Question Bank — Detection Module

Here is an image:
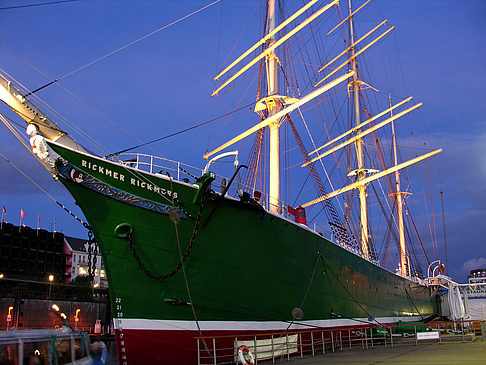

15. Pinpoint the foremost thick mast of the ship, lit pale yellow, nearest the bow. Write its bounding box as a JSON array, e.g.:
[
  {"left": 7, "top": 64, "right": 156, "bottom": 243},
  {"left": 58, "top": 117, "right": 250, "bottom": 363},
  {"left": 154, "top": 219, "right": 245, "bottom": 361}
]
[{"left": 266, "top": 0, "right": 281, "bottom": 213}]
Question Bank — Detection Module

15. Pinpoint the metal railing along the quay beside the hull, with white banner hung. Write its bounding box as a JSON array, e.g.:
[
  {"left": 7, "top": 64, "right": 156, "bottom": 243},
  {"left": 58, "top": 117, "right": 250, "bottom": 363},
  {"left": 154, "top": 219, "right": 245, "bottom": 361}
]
[{"left": 196, "top": 321, "right": 486, "bottom": 365}]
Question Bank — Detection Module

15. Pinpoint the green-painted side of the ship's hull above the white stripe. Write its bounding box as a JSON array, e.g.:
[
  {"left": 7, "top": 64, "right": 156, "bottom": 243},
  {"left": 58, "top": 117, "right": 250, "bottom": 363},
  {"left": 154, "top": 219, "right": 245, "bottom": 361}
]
[{"left": 53, "top": 141, "right": 438, "bottom": 322}]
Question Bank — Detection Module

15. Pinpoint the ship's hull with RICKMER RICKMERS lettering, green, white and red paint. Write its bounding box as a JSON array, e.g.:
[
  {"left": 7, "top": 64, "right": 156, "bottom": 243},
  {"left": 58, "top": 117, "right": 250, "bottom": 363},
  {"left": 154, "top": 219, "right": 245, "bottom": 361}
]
[{"left": 51, "top": 144, "right": 438, "bottom": 364}]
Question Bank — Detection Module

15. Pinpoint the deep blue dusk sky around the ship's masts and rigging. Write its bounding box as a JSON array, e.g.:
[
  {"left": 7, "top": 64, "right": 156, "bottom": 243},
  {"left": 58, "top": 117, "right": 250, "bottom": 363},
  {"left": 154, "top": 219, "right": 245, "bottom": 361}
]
[{"left": 0, "top": 0, "right": 486, "bottom": 281}]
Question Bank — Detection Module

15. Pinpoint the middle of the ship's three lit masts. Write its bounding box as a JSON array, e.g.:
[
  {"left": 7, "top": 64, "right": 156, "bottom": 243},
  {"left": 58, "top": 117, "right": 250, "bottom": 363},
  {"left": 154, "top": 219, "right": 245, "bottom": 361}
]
[{"left": 348, "top": 0, "right": 370, "bottom": 258}]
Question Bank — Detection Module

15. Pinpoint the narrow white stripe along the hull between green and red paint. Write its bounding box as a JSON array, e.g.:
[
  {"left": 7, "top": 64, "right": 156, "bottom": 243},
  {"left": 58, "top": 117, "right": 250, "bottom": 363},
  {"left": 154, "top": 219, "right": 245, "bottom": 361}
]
[{"left": 113, "top": 316, "right": 422, "bottom": 332}]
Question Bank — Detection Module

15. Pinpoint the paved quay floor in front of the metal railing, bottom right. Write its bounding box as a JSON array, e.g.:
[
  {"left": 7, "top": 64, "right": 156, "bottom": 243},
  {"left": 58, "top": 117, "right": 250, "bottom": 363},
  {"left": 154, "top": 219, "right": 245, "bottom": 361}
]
[{"left": 290, "top": 339, "right": 486, "bottom": 365}]
